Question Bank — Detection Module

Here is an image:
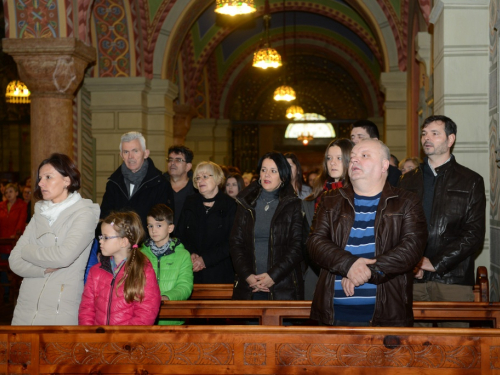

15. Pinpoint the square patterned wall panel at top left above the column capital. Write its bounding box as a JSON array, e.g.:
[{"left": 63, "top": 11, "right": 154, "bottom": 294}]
[{"left": 10, "top": 0, "right": 59, "bottom": 38}]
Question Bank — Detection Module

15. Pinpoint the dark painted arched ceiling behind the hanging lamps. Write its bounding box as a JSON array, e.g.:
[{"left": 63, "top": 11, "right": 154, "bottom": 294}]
[{"left": 164, "top": 0, "right": 408, "bottom": 120}]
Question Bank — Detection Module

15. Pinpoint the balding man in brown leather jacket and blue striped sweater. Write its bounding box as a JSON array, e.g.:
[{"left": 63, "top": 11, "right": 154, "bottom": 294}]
[{"left": 307, "top": 139, "right": 427, "bottom": 326}]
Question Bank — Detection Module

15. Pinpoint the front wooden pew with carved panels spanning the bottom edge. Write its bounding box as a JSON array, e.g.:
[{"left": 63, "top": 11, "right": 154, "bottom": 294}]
[{"left": 0, "top": 326, "right": 500, "bottom": 375}]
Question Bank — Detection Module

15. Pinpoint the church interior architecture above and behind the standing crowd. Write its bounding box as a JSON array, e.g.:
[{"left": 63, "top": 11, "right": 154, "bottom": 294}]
[{"left": 0, "top": 0, "right": 500, "bottom": 301}]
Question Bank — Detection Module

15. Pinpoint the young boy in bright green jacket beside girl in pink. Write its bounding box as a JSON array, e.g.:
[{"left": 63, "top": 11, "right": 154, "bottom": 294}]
[{"left": 141, "top": 203, "right": 193, "bottom": 325}]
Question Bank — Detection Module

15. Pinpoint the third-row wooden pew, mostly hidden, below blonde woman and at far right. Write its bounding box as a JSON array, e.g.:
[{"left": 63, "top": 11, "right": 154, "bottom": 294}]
[{"left": 189, "top": 266, "right": 490, "bottom": 302}]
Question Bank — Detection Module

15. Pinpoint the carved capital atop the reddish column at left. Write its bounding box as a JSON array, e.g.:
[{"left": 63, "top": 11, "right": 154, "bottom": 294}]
[{"left": 2, "top": 38, "right": 96, "bottom": 99}]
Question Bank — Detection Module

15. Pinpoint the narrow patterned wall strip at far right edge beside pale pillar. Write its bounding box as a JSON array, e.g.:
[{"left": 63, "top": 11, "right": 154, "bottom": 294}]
[{"left": 489, "top": 0, "right": 500, "bottom": 301}]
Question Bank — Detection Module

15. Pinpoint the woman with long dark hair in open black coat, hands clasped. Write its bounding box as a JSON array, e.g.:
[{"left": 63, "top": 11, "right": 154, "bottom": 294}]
[{"left": 230, "top": 152, "right": 304, "bottom": 300}]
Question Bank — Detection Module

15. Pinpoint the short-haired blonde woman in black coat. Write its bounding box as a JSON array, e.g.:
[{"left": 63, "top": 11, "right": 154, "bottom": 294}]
[{"left": 175, "top": 161, "right": 236, "bottom": 284}]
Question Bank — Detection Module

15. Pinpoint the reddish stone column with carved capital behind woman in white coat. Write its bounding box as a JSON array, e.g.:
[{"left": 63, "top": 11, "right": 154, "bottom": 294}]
[{"left": 2, "top": 38, "right": 96, "bottom": 181}]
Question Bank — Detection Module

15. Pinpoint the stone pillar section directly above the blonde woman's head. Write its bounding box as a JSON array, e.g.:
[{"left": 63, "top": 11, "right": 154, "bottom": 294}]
[{"left": 185, "top": 119, "right": 232, "bottom": 168}]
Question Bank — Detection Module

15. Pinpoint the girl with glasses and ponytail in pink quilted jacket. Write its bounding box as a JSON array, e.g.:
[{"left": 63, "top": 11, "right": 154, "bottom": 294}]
[{"left": 78, "top": 212, "right": 161, "bottom": 325}]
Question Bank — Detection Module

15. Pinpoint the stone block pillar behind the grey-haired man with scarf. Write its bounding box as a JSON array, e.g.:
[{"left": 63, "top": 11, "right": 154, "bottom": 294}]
[{"left": 84, "top": 77, "right": 178, "bottom": 206}]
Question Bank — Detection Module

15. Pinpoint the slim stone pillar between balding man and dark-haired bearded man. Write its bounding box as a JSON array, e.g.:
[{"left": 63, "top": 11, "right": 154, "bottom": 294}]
[{"left": 380, "top": 72, "right": 407, "bottom": 160}]
